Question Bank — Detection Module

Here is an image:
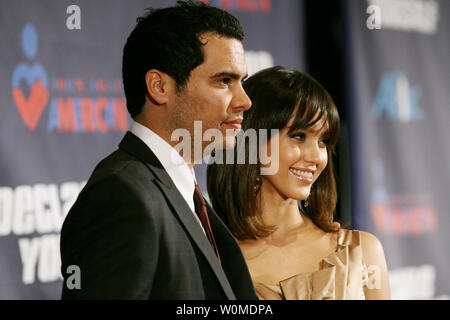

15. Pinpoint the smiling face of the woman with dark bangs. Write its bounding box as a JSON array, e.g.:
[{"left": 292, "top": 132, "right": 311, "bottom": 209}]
[{"left": 261, "top": 117, "right": 328, "bottom": 200}]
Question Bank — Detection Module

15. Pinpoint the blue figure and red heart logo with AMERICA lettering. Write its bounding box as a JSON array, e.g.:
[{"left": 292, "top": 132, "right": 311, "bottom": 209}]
[{"left": 12, "top": 23, "right": 128, "bottom": 133}]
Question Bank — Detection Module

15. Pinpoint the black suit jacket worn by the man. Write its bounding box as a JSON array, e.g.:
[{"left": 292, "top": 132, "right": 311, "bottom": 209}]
[{"left": 61, "top": 132, "right": 257, "bottom": 299}]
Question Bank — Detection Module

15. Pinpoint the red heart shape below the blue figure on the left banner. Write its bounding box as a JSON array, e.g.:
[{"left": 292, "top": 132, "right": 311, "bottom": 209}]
[{"left": 13, "top": 79, "right": 49, "bottom": 131}]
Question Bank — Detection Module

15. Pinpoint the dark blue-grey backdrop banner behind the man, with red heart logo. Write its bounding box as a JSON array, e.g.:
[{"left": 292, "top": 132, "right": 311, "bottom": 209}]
[{"left": 0, "top": 0, "right": 304, "bottom": 299}]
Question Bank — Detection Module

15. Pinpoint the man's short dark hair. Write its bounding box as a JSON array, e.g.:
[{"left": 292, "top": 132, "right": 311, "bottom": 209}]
[{"left": 122, "top": 1, "right": 244, "bottom": 117}]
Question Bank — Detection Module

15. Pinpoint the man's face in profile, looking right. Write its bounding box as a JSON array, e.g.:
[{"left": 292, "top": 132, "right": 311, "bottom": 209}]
[{"left": 172, "top": 33, "right": 251, "bottom": 160}]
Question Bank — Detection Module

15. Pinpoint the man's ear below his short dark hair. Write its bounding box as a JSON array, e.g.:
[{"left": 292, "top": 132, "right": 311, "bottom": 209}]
[{"left": 145, "top": 69, "right": 175, "bottom": 105}]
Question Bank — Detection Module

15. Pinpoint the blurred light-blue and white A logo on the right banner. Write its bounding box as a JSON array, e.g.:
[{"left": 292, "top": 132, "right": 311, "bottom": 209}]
[{"left": 371, "top": 72, "right": 424, "bottom": 122}]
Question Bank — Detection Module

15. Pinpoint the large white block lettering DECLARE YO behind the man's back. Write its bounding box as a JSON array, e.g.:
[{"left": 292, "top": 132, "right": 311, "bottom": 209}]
[{"left": 0, "top": 181, "right": 86, "bottom": 285}]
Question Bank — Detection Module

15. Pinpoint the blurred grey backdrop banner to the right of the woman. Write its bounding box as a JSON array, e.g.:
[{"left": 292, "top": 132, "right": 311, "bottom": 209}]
[{"left": 345, "top": 0, "right": 450, "bottom": 299}]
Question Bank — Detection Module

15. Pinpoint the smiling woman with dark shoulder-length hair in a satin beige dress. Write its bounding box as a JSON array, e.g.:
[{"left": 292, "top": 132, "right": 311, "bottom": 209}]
[{"left": 207, "top": 67, "right": 390, "bottom": 299}]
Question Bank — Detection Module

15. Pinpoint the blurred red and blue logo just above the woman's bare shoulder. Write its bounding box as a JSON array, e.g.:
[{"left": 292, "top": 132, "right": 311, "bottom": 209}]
[{"left": 370, "top": 159, "right": 438, "bottom": 236}]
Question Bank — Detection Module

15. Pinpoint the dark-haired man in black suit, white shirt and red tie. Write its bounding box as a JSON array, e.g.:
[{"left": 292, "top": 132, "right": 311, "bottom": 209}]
[{"left": 61, "top": 1, "right": 257, "bottom": 299}]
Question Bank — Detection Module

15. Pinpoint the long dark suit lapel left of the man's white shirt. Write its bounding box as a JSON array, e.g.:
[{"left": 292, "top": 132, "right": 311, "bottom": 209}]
[{"left": 119, "top": 132, "right": 236, "bottom": 299}]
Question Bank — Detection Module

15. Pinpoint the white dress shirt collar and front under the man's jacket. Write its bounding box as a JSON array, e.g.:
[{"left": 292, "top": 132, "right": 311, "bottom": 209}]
[{"left": 130, "top": 121, "right": 204, "bottom": 231}]
